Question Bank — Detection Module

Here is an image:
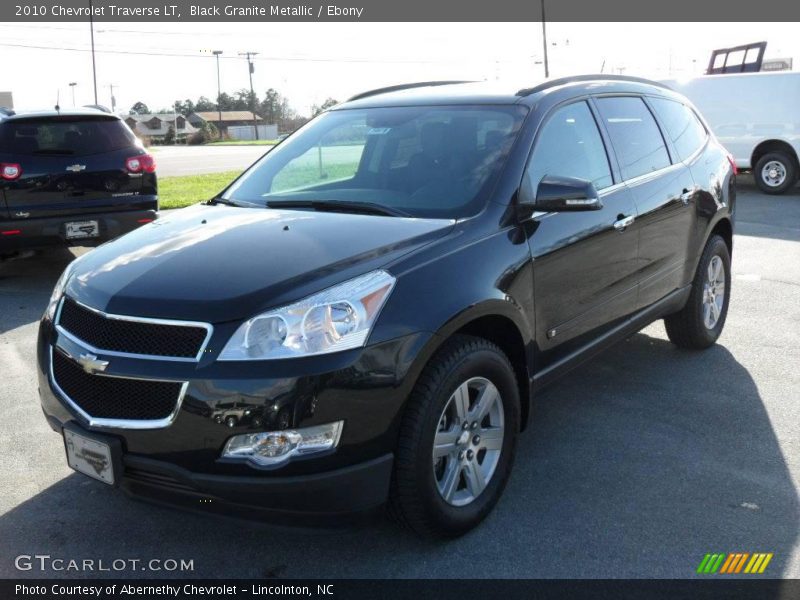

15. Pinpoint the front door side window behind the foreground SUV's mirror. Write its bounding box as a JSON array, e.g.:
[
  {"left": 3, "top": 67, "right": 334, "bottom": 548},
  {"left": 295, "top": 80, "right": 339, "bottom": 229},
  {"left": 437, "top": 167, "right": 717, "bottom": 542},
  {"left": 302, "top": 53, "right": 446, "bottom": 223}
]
[{"left": 525, "top": 102, "right": 613, "bottom": 190}]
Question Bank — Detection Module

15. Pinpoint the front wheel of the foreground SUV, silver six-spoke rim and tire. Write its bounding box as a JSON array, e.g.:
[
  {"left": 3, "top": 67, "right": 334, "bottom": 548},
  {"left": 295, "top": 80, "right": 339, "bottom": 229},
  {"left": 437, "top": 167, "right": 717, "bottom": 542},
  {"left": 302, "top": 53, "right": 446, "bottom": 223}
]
[{"left": 390, "top": 336, "right": 520, "bottom": 538}]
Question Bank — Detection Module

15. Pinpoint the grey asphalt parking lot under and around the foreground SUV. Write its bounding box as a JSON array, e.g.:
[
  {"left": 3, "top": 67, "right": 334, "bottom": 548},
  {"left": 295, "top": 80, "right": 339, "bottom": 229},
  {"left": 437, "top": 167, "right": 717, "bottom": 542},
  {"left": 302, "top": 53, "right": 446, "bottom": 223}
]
[{"left": 0, "top": 177, "right": 800, "bottom": 578}]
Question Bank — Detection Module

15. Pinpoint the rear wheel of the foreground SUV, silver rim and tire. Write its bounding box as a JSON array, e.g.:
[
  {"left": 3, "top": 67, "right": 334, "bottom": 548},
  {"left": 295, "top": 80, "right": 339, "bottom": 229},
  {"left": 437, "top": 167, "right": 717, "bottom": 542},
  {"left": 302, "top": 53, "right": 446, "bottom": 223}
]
[{"left": 664, "top": 235, "right": 731, "bottom": 349}]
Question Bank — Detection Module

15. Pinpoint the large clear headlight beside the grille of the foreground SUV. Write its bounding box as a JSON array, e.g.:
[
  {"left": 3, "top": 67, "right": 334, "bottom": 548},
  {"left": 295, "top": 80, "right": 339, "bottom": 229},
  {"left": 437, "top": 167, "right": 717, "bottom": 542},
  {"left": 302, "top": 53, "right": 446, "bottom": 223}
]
[{"left": 218, "top": 271, "right": 395, "bottom": 360}]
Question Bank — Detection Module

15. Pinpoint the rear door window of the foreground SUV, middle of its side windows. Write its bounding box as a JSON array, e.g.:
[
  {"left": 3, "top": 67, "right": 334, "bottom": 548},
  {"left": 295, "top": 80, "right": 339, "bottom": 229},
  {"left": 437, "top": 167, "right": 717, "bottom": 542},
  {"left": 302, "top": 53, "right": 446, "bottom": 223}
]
[{"left": 597, "top": 97, "right": 670, "bottom": 179}]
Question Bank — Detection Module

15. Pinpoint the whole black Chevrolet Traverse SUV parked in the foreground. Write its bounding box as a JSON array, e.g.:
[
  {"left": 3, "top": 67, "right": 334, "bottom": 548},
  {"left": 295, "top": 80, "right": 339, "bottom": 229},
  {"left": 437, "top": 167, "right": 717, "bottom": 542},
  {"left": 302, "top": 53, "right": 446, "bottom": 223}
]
[{"left": 38, "top": 76, "right": 735, "bottom": 537}]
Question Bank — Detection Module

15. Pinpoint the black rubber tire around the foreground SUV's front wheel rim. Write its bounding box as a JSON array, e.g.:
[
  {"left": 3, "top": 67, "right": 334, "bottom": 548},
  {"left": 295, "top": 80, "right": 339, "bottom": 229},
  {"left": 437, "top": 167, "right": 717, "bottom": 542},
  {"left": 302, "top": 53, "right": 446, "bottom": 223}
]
[{"left": 389, "top": 335, "right": 520, "bottom": 538}]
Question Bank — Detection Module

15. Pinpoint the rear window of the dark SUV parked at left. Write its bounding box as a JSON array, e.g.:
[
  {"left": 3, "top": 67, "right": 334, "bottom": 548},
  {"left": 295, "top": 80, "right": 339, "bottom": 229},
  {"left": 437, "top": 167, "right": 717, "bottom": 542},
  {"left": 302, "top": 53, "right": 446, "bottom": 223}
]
[{"left": 0, "top": 118, "right": 136, "bottom": 156}]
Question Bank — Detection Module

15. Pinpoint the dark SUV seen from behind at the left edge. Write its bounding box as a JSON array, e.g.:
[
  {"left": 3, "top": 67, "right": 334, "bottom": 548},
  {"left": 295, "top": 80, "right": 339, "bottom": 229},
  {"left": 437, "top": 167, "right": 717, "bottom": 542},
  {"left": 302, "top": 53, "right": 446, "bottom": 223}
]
[{"left": 0, "top": 108, "right": 158, "bottom": 254}]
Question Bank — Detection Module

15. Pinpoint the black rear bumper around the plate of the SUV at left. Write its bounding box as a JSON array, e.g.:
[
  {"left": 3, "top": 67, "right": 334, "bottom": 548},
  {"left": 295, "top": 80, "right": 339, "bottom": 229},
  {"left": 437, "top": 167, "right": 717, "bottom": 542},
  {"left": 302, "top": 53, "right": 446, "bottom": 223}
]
[{"left": 0, "top": 210, "right": 158, "bottom": 252}]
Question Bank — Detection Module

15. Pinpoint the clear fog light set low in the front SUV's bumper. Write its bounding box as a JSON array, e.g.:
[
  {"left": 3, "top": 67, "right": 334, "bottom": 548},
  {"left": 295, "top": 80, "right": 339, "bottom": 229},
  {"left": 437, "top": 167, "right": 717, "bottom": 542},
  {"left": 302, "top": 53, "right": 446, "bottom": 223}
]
[{"left": 222, "top": 421, "right": 344, "bottom": 467}]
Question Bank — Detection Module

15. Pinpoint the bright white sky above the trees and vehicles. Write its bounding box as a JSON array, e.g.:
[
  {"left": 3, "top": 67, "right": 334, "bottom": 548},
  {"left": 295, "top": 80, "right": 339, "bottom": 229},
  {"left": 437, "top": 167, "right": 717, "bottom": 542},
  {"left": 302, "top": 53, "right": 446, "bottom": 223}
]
[{"left": 0, "top": 23, "right": 800, "bottom": 114}]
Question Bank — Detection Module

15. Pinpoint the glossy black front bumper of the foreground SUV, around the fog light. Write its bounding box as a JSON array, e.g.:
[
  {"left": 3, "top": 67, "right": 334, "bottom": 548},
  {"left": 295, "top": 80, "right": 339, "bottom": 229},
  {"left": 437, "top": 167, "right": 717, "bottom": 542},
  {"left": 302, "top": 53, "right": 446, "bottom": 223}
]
[{"left": 38, "top": 319, "right": 430, "bottom": 524}]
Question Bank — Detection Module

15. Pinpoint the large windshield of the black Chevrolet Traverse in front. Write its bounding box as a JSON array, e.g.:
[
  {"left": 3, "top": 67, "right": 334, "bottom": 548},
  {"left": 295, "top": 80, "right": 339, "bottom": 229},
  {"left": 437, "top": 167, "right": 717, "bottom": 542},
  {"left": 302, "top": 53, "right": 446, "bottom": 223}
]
[{"left": 222, "top": 106, "right": 526, "bottom": 218}]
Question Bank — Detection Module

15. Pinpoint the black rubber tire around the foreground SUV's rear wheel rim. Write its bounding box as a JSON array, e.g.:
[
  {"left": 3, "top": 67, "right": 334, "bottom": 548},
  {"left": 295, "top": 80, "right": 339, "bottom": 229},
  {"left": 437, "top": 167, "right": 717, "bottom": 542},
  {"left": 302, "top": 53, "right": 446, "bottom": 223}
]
[{"left": 664, "top": 235, "right": 731, "bottom": 350}]
